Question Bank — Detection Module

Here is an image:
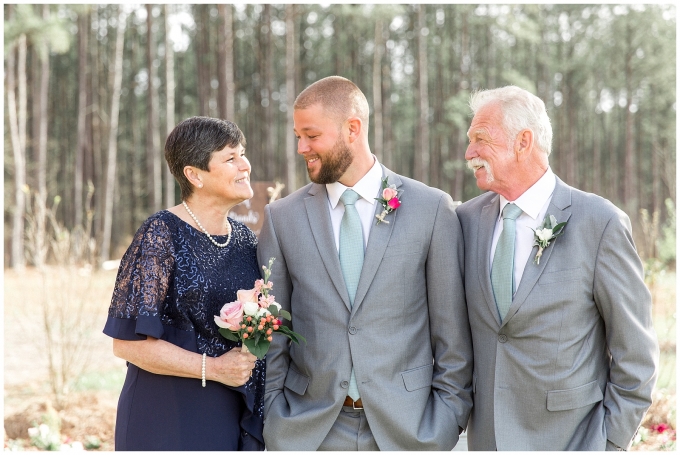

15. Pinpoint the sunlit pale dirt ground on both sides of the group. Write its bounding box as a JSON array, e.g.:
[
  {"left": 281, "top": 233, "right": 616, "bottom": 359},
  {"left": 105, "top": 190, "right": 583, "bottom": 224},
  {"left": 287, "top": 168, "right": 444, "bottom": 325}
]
[{"left": 3, "top": 269, "right": 676, "bottom": 451}]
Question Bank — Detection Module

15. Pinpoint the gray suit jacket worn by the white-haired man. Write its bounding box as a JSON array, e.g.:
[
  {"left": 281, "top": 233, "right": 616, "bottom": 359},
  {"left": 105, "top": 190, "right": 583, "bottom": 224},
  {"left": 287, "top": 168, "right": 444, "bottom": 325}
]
[{"left": 456, "top": 179, "right": 658, "bottom": 450}]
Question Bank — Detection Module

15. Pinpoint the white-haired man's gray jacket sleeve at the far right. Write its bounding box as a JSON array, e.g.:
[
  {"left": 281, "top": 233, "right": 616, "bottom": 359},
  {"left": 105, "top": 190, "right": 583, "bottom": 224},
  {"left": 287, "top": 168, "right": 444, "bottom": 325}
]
[{"left": 596, "top": 211, "right": 659, "bottom": 448}]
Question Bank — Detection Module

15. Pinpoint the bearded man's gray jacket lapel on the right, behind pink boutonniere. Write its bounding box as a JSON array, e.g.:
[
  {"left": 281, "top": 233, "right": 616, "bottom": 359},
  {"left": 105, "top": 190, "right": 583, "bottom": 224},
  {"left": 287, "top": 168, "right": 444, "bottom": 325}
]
[{"left": 354, "top": 166, "right": 401, "bottom": 313}]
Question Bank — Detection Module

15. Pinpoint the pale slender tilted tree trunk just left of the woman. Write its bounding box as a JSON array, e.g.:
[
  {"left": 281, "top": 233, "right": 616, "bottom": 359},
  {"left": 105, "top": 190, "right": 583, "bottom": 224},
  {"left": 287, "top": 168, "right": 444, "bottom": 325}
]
[{"left": 99, "top": 5, "right": 126, "bottom": 262}]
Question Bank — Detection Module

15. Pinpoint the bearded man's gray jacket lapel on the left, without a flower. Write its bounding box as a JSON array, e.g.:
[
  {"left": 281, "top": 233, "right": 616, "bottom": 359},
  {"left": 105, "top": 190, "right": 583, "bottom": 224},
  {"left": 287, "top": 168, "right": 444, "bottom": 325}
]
[{"left": 305, "top": 184, "right": 354, "bottom": 311}]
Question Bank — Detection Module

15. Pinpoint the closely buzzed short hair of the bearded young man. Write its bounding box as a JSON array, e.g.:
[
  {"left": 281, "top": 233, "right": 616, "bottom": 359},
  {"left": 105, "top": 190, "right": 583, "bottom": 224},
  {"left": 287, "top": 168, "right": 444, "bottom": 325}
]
[{"left": 293, "top": 76, "right": 368, "bottom": 131}]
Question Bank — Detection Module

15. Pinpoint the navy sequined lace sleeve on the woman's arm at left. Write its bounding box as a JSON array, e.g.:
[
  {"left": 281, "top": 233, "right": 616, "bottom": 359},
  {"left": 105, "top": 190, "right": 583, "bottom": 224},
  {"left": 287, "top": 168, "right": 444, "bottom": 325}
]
[{"left": 104, "top": 217, "right": 175, "bottom": 340}]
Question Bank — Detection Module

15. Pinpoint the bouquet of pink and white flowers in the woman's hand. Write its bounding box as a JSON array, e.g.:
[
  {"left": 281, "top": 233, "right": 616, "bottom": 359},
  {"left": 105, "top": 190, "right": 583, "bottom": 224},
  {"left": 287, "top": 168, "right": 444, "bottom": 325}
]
[{"left": 215, "top": 258, "right": 306, "bottom": 359}]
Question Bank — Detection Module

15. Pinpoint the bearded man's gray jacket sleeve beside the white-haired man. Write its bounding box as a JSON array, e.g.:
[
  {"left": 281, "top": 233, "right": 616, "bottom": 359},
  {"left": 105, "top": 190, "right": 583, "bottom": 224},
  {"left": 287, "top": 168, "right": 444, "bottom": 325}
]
[{"left": 421, "top": 194, "right": 472, "bottom": 432}]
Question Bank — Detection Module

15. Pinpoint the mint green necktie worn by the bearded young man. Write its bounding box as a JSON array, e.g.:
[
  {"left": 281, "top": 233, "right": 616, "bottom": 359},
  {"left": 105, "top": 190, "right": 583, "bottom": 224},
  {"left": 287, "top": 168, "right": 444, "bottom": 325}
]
[{"left": 339, "top": 188, "right": 364, "bottom": 401}]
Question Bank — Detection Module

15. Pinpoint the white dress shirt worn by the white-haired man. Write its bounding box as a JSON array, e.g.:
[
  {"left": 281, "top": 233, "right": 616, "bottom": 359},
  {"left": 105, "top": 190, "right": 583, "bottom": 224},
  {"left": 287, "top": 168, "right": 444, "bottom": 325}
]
[{"left": 489, "top": 167, "right": 556, "bottom": 295}]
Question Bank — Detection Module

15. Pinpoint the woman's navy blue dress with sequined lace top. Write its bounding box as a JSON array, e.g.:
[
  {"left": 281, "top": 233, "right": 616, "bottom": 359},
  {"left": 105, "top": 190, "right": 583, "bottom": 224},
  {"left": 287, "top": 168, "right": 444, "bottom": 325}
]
[{"left": 104, "top": 210, "right": 265, "bottom": 450}]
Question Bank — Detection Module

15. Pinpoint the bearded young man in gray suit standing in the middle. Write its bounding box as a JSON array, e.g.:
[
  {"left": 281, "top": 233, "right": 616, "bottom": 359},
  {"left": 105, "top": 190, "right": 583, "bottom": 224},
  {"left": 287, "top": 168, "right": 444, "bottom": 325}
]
[{"left": 258, "top": 76, "right": 472, "bottom": 450}]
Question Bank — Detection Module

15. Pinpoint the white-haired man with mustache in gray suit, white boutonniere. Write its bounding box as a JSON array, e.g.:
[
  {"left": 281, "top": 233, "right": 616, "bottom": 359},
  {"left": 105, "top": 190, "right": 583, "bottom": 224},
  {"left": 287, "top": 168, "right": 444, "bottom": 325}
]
[{"left": 456, "top": 86, "right": 658, "bottom": 450}]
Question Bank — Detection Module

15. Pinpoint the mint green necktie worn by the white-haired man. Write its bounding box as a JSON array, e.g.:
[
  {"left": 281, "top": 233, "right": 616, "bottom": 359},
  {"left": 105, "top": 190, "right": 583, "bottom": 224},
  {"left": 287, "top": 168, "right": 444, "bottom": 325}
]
[{"left": 491, "top": 204, "right": 522, "bottom": 321}]
